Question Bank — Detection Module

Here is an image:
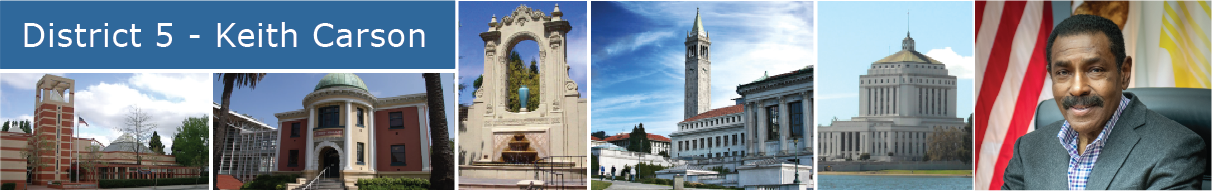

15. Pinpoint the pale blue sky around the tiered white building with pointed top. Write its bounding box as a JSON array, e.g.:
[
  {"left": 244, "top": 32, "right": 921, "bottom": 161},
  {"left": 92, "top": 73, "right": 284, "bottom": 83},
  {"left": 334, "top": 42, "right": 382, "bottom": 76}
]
[{"left": 817, "top": 1, "right": 976, "bottom": 125}]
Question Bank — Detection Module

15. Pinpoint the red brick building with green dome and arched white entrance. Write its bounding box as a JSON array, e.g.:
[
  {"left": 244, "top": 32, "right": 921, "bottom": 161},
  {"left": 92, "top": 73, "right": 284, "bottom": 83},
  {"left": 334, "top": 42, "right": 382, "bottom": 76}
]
[{"left": 274, "top": 74, "right": 430, "bottom": 183}]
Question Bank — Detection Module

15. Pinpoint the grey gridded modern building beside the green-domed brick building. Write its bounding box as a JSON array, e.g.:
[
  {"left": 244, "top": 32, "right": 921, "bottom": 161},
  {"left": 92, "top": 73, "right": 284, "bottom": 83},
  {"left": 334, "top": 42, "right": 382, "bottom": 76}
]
[{"left": 211, "top": 104, "right": 278, "bottom": 181}]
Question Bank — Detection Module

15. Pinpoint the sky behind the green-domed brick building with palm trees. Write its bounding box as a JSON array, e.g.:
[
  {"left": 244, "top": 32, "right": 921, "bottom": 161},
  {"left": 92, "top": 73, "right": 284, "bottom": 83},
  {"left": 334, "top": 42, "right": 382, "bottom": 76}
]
[{"left": 211, "top": 74, "right": 457, "bottom": 139}]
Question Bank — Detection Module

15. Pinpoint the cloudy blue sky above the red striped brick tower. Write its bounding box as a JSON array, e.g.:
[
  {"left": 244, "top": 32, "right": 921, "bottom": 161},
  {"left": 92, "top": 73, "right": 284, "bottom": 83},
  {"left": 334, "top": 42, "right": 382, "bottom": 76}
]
[{"left": 0, "top": 74, "right": 211, "bottom": 152}]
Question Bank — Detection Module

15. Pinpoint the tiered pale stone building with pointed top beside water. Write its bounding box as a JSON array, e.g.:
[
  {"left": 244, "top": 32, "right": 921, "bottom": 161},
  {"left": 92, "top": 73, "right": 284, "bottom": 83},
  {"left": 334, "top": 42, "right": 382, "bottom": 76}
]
[{"left": 819, "top": 33, "right": 965, "bottom": 161}]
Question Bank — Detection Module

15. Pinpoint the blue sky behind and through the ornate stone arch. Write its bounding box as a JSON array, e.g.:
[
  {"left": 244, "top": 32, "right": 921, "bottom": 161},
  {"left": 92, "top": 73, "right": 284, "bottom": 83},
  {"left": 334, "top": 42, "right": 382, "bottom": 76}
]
[{"left": 458, "top": 1, "right": 589, "bottom": 104}]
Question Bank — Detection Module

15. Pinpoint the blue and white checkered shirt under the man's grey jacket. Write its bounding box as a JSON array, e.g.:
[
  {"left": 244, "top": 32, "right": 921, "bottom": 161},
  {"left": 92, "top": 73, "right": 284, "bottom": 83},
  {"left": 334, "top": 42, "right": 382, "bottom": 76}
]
[{"left": 1057, "top": 94, "right": 1131, "bottom": 191}]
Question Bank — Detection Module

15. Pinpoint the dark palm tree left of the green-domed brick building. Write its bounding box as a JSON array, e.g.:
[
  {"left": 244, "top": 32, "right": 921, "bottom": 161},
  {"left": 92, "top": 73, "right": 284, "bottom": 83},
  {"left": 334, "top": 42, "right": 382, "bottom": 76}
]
[{"left": 211, "top": 73, "right": 265, "bottom": 190}]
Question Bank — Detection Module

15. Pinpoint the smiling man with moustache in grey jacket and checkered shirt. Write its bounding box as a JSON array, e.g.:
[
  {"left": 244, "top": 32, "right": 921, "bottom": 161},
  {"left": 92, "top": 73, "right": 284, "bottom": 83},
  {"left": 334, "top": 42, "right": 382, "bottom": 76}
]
[{"left": 1001, "top": 15, "right": 1205, "bottom": 191}]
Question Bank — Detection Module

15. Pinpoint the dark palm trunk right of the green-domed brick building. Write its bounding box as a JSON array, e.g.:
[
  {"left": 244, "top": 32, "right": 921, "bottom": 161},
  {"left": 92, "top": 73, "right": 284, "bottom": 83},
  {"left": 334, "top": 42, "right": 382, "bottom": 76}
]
[{"left": 422, "top": 73, "right": 455, "bottom": 190}]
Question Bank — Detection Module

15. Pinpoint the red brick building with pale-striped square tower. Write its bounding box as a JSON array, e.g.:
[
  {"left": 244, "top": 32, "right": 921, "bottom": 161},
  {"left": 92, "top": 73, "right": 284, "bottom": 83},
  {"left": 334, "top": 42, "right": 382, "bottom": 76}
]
[{"left": 0, "top": 75, "right": 204, "bottom": 190}]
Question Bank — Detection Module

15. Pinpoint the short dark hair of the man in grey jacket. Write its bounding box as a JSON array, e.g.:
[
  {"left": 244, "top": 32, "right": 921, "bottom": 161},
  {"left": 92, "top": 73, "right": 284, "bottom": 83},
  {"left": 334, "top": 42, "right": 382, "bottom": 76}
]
[{"left": 1045, "top": 15, "right": 1127, "bottom": 73}]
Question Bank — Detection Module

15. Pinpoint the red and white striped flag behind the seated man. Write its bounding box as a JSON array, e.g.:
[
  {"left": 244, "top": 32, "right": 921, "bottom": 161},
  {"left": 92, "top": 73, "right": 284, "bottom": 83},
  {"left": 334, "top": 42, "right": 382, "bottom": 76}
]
[{"left": 974, "top": 0, "right": 1052, "bottom": 190}]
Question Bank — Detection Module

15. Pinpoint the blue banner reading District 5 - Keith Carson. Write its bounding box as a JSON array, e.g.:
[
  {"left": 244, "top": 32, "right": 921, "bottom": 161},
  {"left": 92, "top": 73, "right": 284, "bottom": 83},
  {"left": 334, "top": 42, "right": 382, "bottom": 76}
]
[{"left": 0, "top": 0, "right": 457, "bottom": 69}]
